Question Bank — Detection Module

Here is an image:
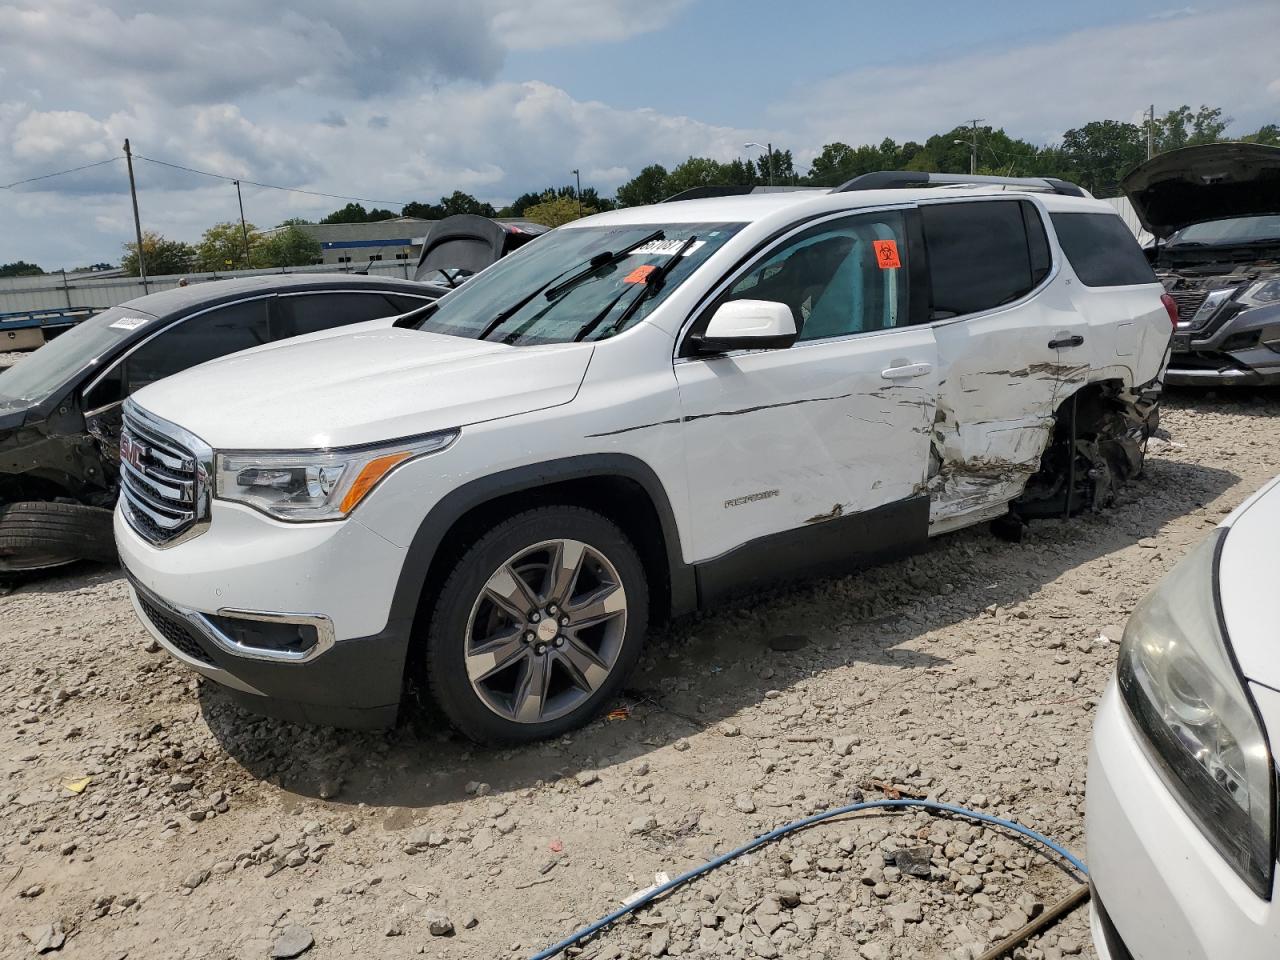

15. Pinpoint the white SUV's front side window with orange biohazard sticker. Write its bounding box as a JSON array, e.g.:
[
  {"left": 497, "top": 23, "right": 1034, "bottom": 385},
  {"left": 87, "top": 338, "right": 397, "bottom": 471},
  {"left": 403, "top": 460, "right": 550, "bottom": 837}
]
[{"left": 721, "top": 211, "right": 909, "bottom": 340}]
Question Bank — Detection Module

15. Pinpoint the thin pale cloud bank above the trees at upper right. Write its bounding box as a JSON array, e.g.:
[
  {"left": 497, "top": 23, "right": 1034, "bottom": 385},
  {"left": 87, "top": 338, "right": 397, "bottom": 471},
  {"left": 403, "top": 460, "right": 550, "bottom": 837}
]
[{"left": 768, "top": 0, "right": 1280, "bottom": 156}]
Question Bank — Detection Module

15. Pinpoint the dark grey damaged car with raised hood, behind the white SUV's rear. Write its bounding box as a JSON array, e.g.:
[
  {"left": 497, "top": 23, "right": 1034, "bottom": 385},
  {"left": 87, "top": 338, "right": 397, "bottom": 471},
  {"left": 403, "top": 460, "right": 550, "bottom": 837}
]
[{"left": 1121, "top": 143, "right": 1280, "bottom": 387}]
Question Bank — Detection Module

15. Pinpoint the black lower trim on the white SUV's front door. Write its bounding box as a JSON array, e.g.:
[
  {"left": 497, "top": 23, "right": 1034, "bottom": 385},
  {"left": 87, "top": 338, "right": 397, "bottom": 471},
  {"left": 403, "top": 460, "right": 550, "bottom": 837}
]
[{"left": 696, "top": 494, "right": 929, "bottom": 607}]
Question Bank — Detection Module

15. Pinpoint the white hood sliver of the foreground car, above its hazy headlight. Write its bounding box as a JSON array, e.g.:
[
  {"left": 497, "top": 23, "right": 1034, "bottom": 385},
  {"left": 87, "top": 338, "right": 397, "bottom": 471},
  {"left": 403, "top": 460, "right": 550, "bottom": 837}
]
[{"left": 1217, "top": 477, "right": 1280, "bottom": 690}]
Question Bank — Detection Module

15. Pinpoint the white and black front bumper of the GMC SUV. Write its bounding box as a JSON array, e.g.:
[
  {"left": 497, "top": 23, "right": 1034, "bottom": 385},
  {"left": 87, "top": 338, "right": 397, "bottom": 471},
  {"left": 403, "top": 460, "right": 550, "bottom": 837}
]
[{"left": 115, "top": 507, "right": 411, "bottom": 728}]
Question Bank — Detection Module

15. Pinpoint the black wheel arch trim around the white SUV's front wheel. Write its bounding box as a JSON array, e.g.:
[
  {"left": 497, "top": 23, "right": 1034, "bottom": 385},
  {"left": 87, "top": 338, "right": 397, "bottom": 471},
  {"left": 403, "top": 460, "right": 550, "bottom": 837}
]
[{"left": 390, "top": 453, "right": 698, "bottom": 670}]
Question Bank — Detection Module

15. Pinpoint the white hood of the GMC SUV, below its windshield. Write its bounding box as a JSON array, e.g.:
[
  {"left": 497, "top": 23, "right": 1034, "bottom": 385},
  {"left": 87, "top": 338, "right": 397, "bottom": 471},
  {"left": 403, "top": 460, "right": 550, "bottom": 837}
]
[{"left": 134, "top": 328, "right": 593, "bottom": 449}]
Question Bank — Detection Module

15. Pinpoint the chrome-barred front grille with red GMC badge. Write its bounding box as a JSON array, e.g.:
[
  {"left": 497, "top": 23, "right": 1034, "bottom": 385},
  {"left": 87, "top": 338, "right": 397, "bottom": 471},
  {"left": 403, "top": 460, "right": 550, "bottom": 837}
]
[{"left": 120, "top": 399, "right": 214, "bottom": 548}]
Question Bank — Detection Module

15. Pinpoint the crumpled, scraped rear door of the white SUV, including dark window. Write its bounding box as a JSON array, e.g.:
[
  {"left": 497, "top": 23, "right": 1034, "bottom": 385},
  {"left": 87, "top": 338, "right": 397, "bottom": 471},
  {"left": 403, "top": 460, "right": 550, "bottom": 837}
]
[{"left": 920, "top": 197, "right": 1089, "bottom": 534}]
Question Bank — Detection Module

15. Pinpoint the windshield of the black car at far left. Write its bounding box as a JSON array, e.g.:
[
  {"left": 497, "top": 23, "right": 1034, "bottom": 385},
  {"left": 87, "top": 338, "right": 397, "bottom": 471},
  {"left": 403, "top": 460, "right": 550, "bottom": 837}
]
[{"left": 0, "top": 306, "right": 155, "bottom": 402}]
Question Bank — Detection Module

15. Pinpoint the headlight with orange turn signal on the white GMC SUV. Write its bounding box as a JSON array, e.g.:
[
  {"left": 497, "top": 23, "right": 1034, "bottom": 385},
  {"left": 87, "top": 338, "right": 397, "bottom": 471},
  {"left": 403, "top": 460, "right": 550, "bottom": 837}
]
[{"left": 214, "top": 430, "right": 458, "bottom": 521}]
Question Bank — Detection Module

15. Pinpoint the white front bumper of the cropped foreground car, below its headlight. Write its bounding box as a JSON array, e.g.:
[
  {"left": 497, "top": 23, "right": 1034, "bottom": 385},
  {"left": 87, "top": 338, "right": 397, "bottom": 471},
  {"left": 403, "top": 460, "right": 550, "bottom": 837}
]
[{"left": 1085, "top": 681, "right": 1280, "bottom": 960}]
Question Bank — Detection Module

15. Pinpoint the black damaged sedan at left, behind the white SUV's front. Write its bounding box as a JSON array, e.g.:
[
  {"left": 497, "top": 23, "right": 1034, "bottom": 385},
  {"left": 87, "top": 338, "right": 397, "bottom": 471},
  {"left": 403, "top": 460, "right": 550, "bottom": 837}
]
[{"left": 0, "top": 274, "right": 448, "bottom": 573}]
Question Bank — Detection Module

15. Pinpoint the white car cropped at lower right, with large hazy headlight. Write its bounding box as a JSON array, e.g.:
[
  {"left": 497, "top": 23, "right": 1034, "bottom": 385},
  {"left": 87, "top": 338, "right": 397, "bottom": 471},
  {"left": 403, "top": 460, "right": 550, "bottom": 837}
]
[{"left": 1087, "top": 479, "right": 1280, "bottom": 960}]
